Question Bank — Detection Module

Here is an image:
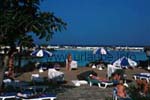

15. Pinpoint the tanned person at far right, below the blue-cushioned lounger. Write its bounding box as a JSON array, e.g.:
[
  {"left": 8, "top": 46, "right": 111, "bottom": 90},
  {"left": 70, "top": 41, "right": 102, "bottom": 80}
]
[{"left": 136, "top": 79, "right": 148, "bottom": 96}]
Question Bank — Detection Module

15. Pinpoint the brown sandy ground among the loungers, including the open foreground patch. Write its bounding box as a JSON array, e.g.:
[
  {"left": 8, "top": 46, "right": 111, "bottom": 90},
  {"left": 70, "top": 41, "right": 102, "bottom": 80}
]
[{"left": 13, "top": 67, "right": 148, "bottom": 100}]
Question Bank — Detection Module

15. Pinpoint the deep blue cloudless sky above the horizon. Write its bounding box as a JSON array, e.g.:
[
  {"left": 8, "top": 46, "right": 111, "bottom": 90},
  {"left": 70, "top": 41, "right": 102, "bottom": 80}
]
[{"left": 35, "top": 0, "right": 150, "bottom": 46}]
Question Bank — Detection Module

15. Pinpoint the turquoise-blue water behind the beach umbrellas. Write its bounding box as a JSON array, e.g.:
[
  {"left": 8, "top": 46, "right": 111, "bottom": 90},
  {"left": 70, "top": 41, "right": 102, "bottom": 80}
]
[{"left": 17, "top": 49, "right": 148, "bottom": 67}]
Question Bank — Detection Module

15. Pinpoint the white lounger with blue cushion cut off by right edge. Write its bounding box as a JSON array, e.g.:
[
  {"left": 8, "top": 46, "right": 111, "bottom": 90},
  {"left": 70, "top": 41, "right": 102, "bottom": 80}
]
[{"left": 133, "top": 73, "right": 150, "bottom": 83}]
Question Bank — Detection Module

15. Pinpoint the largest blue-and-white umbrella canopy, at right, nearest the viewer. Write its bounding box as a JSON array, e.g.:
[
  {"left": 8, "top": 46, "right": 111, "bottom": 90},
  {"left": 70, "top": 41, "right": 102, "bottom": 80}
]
[{"left": 113, "top": 57, "right": 137, "bottom": 67}]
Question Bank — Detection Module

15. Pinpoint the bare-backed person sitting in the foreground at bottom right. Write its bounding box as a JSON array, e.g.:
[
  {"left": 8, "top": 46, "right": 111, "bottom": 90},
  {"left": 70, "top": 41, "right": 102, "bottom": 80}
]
[{"left": 116, "top": 80, "right": 131, "bottom": 100}]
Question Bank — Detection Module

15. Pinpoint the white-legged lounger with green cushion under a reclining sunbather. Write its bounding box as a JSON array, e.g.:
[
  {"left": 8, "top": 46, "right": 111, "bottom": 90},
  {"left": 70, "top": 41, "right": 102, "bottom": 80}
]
[{"left": 87, "top": 76, "right": 113, "bottom": 89}]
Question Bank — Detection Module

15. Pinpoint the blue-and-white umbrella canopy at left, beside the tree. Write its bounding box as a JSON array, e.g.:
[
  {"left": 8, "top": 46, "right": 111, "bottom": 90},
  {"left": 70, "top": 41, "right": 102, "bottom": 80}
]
[{"left": 31, "top": 50, "right": 52, "bottom": 57}]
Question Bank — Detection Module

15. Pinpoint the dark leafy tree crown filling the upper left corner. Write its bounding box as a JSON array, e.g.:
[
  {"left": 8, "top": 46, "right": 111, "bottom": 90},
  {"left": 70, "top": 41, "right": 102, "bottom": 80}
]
[{"left": 0, "top": 0, "right": 66, "bottom": 89}]
